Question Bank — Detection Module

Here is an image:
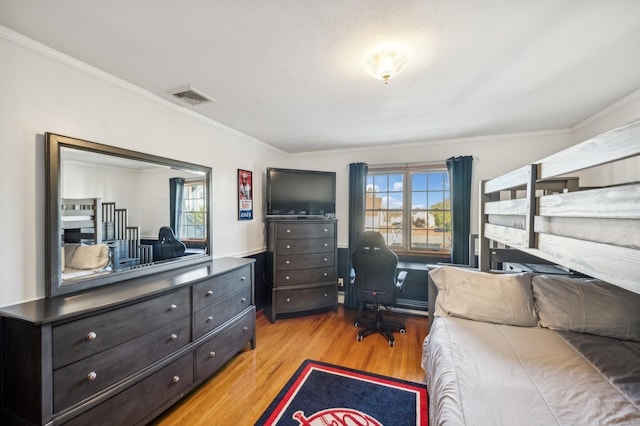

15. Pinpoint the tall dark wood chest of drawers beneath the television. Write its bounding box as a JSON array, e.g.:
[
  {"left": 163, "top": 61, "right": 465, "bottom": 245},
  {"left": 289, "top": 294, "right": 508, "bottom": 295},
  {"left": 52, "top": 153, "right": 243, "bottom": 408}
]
[{"left": 267, "top": 219, "right": 338, "bottom": 322}]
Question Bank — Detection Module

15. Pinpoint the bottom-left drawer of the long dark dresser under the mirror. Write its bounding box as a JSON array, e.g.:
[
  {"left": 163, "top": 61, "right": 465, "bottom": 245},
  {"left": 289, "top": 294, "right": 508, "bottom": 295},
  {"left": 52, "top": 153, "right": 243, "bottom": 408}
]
[{"left": 65, "top": 353, "right": 194, "bottom": 426}]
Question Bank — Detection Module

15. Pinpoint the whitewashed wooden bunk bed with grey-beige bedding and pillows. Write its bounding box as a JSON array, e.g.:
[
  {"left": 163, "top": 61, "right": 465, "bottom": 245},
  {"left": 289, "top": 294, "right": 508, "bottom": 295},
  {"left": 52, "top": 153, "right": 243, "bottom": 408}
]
[{"left": 422, "top": 120, "right": 640, "bottom": 425}]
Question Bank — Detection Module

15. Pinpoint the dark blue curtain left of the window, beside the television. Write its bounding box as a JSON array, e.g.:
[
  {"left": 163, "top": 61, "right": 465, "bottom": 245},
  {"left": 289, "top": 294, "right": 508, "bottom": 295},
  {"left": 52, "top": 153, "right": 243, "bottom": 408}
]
[{"left": 344, "top": 163, "right": 369, "bottom": 309}]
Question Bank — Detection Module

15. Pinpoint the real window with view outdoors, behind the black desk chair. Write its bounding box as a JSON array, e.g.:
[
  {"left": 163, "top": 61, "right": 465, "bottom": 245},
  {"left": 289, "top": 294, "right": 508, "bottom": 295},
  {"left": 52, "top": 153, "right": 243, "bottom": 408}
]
[{"left": 364, "top": 164, "right": 451, "bottom": 253}]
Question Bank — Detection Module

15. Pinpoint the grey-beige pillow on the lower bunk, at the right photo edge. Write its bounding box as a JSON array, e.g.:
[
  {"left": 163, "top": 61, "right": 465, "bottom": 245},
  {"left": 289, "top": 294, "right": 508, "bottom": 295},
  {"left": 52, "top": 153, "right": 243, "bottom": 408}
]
[{"left": 532, "top": 275, "right": 640, "bottom": 341}]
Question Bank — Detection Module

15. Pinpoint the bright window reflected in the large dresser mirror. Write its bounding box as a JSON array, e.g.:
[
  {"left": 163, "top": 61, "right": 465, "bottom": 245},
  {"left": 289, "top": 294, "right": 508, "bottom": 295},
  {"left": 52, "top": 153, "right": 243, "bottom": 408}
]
[{"left": 178, "top": 179, "right": 207, "bottom": 241}]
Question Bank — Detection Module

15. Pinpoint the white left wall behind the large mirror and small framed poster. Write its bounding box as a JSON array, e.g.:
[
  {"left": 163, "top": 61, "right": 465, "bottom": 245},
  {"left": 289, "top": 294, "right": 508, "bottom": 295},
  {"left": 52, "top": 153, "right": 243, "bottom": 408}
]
[{"left": 0, "top": 27, "right": 286, "bottom": 306}]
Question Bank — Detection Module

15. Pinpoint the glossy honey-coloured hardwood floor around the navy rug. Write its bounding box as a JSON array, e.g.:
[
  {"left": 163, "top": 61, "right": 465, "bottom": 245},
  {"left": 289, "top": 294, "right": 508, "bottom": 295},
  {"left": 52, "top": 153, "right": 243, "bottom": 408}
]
[{"left": 154, "top": 306, "right": 427, "bottom": 426}]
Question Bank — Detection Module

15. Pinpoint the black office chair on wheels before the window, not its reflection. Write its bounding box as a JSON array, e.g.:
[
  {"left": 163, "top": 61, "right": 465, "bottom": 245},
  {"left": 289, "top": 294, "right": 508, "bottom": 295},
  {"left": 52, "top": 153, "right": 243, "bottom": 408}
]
[{"left": 351, "top": 231, "right": 407, "bottom": 346}]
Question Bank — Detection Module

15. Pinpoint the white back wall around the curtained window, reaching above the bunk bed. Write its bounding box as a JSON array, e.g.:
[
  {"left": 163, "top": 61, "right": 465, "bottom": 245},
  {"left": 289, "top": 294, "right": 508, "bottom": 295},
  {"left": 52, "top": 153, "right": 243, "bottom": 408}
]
[{"left": 289, "top": 90, "right": 640, "bottom": 247}]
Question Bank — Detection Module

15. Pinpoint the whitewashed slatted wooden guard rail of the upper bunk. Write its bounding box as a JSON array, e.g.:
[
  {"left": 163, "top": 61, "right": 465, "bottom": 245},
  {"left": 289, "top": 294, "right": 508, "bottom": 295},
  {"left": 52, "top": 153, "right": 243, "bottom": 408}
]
[{"left": 479, "top": 120, "right": 640, "bottom": 293}]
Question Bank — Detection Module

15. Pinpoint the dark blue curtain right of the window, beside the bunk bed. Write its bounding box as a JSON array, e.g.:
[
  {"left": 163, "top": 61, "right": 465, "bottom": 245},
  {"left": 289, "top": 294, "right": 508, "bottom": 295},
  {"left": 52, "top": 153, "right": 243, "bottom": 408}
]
[{"left": 447, "top": 156, "right": 473, "bottom": 265}]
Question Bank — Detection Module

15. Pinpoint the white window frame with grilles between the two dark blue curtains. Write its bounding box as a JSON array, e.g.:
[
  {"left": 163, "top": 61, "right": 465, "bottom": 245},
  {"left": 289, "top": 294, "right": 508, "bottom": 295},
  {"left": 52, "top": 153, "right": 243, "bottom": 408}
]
[{"left": 365, "top": 161, "right": 452, "bottom": 257}]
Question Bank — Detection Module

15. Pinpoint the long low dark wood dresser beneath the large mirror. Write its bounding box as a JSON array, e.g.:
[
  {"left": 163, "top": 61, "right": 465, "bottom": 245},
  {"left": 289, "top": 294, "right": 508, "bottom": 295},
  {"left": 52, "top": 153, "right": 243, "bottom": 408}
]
[{"left": 0, "top": 258, "right": 256, "bottom": 425}]
